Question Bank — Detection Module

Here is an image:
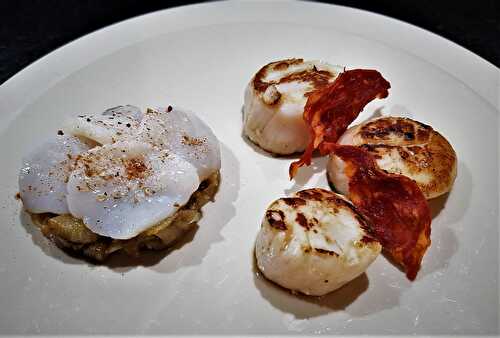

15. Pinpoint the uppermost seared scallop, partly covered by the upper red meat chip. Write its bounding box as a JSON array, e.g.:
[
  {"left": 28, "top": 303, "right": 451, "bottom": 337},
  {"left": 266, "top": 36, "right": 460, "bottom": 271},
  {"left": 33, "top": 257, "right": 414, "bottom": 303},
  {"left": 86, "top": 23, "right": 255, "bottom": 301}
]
[{"left": 243, "top": 59, "right": 343, "bottom": 155}]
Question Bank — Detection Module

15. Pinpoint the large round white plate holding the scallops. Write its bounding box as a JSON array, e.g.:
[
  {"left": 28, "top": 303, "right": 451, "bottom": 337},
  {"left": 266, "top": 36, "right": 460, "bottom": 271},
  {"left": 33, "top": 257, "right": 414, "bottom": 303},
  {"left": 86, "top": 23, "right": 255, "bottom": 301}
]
[{"left": 0, "top": 2, "right": 499, "bottom": 334}]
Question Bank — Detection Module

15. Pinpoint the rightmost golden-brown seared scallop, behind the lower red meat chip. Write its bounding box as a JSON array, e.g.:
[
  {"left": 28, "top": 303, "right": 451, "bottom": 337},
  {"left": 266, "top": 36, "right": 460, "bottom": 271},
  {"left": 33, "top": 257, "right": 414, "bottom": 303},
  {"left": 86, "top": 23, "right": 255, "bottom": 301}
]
[{"left": 336, "top": 116, "right": 457, "bottom": 199}]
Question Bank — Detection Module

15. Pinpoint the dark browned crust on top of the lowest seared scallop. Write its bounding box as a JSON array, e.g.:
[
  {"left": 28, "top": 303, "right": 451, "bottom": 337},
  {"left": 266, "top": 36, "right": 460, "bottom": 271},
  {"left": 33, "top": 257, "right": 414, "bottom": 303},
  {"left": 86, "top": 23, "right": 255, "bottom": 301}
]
[{"left": 264, "top": 188, "right": 376, "bottom": 255}]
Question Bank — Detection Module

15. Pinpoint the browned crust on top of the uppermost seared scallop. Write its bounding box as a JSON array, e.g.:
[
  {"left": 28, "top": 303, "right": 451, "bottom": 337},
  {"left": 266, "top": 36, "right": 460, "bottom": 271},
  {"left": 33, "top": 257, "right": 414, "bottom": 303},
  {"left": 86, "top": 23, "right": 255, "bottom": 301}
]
[{"left": 253, "top": 59, "right": 336, "bottom": 96}]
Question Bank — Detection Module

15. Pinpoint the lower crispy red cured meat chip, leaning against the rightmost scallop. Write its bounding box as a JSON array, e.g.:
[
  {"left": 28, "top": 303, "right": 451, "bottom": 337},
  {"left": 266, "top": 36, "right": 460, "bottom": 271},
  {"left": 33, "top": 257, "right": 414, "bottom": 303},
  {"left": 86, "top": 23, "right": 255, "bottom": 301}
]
[{"left": 329, "top": 145, "right": 431, "bottom": 280}]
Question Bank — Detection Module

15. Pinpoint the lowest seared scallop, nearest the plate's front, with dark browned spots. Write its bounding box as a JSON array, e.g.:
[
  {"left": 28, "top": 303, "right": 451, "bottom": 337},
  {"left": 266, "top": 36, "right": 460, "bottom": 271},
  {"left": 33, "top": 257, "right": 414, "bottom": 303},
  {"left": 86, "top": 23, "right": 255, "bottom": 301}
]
[{"left": 255, "top": 189, "right": 381, "bottom": 296}]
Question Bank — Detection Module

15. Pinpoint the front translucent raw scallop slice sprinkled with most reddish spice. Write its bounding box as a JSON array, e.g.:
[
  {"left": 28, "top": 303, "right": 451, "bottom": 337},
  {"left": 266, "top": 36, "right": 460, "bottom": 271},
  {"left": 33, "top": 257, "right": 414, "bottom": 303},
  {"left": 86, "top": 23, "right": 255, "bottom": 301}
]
[{"left": 67, "top": 140, "right": 200, "bottom": 239}]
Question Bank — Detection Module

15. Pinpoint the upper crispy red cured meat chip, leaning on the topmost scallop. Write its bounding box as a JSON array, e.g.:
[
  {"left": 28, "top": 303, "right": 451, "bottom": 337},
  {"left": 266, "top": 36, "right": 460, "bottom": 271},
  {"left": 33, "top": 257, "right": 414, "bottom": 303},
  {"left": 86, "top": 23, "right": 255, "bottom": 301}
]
[{"left": 289, "top": 69, "right": 391, "bottom": 179}]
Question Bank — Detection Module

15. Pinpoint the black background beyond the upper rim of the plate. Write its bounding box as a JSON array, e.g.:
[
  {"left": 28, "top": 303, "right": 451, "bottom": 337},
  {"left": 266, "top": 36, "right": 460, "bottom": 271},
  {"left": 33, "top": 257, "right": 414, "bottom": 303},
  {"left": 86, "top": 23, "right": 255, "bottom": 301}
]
[{"left": 0, "top": 0, "right": 500, "bottom": 84}]
